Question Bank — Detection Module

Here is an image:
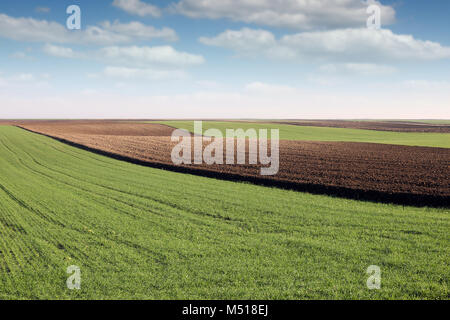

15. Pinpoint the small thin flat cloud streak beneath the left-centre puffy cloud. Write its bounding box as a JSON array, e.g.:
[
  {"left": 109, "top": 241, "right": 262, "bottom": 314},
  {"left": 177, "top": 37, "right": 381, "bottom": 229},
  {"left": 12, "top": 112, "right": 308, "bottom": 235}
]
[{"left": 103, "top": 66, "right": 187, "bottom": 80}]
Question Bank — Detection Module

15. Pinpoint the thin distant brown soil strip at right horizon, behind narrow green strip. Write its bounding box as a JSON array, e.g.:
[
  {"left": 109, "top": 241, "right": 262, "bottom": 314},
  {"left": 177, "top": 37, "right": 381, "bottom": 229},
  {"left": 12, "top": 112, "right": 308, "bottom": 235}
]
[{"left": 273, "top": 120, "right": 450, "bottom": 133}]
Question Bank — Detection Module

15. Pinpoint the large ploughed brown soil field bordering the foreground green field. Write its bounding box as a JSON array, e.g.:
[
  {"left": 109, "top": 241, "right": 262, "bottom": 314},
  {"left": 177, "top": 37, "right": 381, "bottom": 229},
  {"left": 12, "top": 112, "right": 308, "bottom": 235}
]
[{"left": 14, "top": 121, "right": 450, "bottom": 207}]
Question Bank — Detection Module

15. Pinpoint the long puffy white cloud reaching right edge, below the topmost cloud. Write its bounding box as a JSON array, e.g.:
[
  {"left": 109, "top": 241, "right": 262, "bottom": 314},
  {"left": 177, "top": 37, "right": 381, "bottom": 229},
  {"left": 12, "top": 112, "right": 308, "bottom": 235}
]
[{"left": 199, "top": 28, "right": 450, "bottom": 62}]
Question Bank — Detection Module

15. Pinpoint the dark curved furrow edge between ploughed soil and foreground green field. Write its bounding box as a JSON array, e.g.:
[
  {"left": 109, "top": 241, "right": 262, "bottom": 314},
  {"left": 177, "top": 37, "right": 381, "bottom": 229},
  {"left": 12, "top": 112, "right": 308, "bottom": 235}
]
[{"left": 17, "top": 126, "right": 450, "bottom": 208}]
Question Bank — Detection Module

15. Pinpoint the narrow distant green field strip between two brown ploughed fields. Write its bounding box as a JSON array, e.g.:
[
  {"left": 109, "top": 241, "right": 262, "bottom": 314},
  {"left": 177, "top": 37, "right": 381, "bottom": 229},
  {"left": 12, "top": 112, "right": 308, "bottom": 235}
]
[{"left": 158, "top": 121, "right": 450, "bottom": 148}]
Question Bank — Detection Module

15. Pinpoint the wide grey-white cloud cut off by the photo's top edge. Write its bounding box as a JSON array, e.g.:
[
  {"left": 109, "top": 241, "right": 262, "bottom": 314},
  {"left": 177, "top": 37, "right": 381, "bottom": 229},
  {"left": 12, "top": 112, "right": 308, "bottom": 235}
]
[{"left": 171, "top": 0, "right": 395, "bottom": 30}]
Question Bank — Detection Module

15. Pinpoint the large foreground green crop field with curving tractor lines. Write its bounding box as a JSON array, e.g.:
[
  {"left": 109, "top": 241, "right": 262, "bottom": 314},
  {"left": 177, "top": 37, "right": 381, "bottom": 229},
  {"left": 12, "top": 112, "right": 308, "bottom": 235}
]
[{"left": 0, "top": 126, "right": 450, "bottom": 299}]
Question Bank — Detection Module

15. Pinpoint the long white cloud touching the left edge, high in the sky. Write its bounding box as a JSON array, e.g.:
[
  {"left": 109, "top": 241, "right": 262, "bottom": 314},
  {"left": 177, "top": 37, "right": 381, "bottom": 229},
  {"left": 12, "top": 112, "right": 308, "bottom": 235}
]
[{"left": 0, "top": 14, "right": 177, "bottom": 45}]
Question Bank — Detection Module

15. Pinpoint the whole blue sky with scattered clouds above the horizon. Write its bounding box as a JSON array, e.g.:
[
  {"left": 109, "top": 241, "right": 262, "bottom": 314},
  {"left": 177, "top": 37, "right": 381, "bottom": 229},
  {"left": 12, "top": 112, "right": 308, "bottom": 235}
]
[{"left": 0, "top": 0, "right": 450, "bottom": 119}]
